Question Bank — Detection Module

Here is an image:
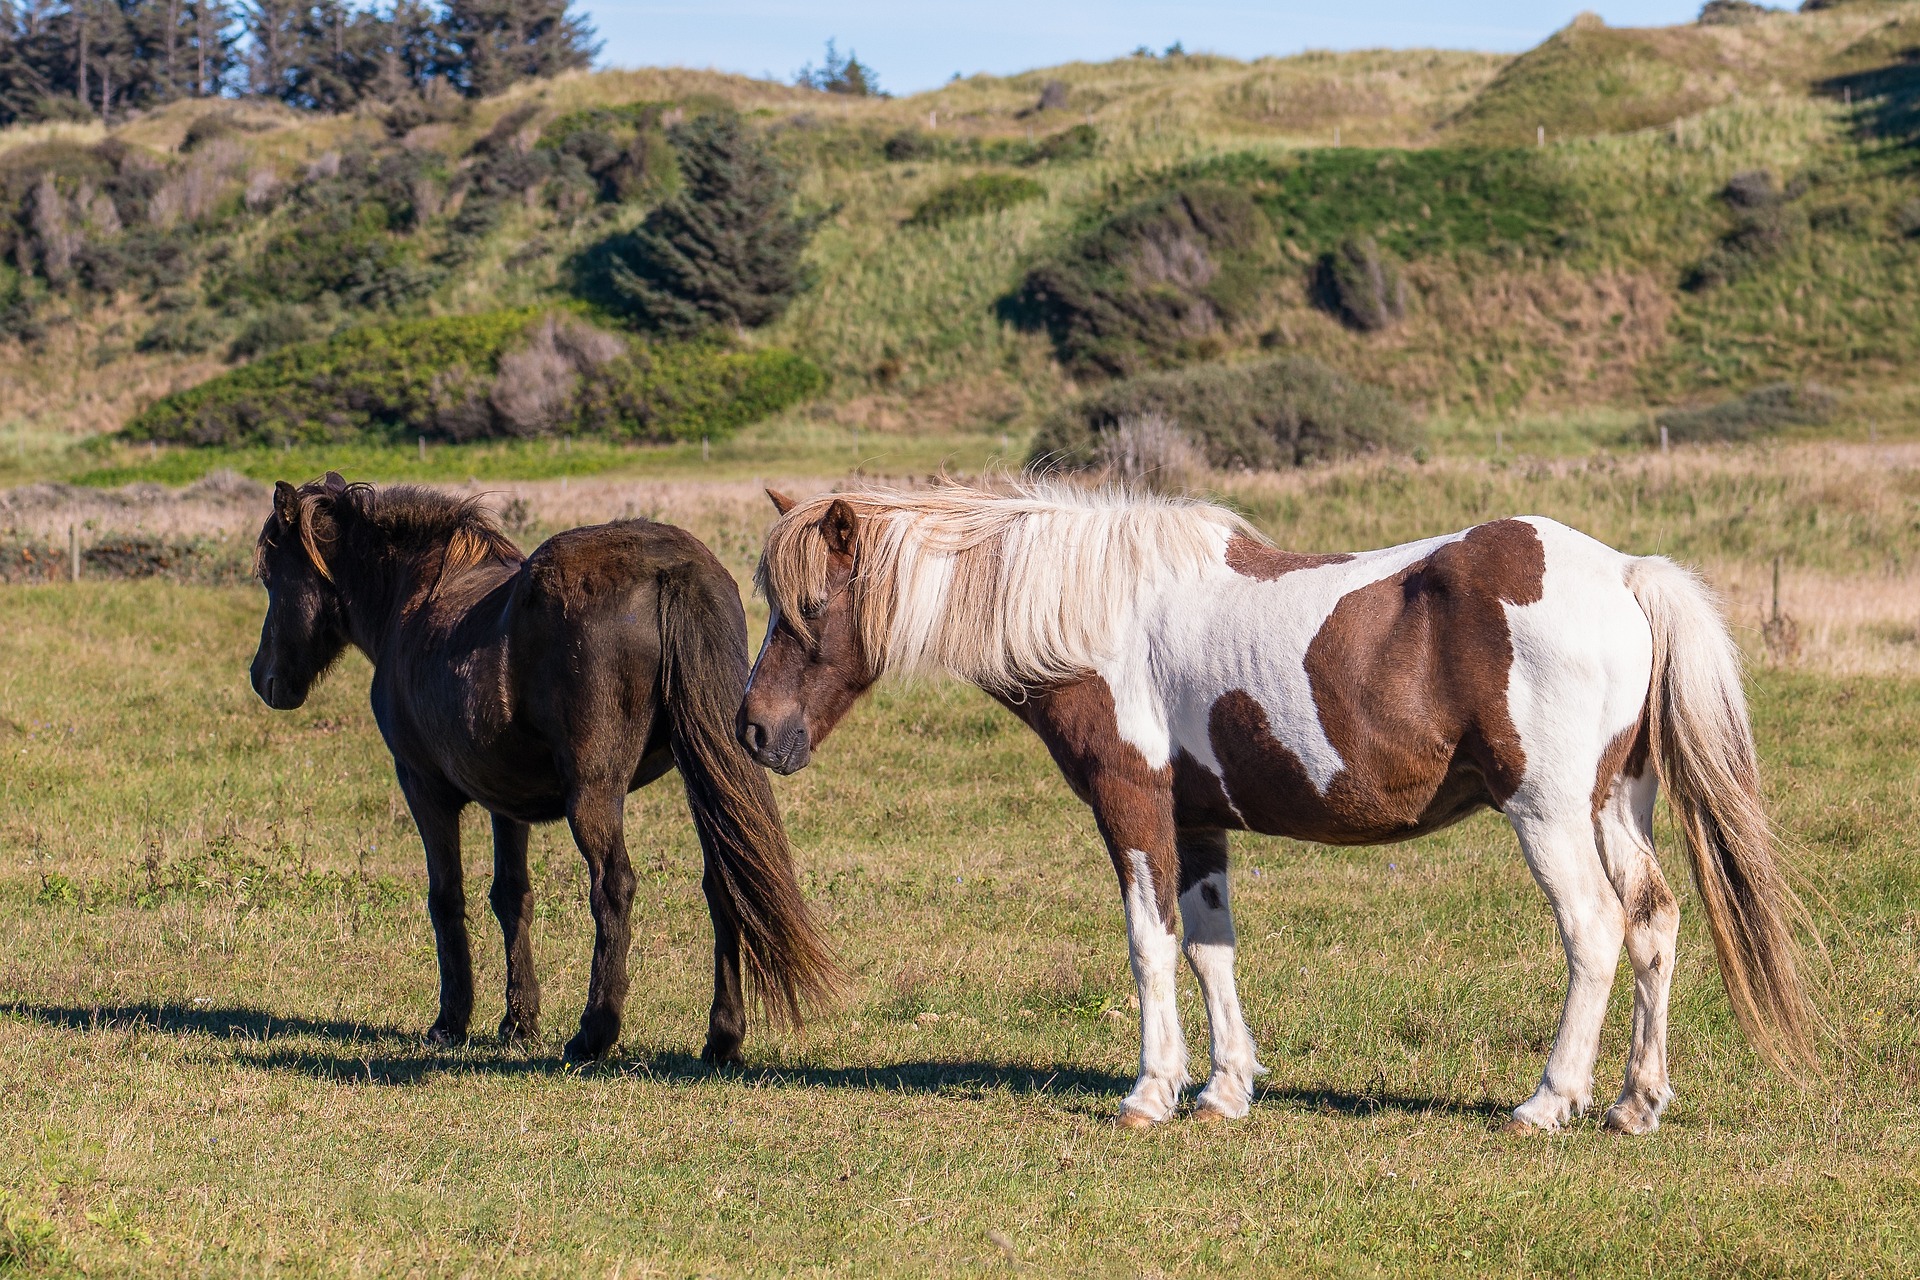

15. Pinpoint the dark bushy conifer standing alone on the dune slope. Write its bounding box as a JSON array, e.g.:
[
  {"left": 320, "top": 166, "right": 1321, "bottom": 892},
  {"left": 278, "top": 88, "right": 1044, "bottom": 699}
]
[{"left": 609, "top": 115, "right": 816, "bottom": 334}]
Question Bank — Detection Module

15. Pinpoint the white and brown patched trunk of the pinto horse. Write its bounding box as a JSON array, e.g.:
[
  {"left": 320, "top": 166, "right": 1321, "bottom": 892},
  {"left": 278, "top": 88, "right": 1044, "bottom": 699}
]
[{"left": 1156, "top": 518, "right": 1647, "bottom": 842}]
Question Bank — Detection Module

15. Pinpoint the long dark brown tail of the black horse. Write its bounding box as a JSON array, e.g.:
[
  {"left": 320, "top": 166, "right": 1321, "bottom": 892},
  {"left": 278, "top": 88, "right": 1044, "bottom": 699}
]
[{"left": 660, "top": 560, "right": 843, "bottom": 1027}]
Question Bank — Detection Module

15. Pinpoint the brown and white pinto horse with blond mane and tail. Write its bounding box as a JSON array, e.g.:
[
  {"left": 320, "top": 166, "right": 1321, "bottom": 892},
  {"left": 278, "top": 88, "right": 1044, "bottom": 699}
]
[{"left": 741, "top": 486, "right": 1814, "bottom": 1132}]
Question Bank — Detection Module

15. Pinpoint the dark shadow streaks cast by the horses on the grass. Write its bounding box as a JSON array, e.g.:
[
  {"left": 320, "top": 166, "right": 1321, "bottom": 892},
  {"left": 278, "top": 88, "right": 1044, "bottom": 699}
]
[{"left": 11, "top": 1002, "right": 1507, "bottom": 1121}]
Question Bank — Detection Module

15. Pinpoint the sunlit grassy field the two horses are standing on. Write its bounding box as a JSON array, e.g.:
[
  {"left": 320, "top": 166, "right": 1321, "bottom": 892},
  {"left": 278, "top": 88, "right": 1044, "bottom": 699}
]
[{"left": 0, "top": 468, "right": 1920, "bottom": 1276}]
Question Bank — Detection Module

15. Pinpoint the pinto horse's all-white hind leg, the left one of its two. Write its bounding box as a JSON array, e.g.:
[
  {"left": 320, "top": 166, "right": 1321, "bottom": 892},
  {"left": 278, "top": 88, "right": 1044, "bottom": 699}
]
[{"left": 1507, "top": 798, "right": 1626, "bottom": 1128}]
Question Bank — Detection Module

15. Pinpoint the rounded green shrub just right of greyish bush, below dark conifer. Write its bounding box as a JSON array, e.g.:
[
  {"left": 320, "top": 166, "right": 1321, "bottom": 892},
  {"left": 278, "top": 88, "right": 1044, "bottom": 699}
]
[{"left": 576, "top": 344, "right": 826, "bottom": 441}]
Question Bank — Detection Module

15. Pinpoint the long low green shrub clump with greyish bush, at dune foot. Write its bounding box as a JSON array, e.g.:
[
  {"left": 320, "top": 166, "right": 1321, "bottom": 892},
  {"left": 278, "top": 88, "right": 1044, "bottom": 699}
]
[{"left": 123, "top": 309, "right": 822, "bottom": 447}]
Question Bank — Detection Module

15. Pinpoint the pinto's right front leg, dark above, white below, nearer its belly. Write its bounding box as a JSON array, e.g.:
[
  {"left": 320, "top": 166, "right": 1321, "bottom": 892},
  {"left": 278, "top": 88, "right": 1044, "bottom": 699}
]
[{"left": 1179, "top": 829, "right": 1267, "bottom": 1121}]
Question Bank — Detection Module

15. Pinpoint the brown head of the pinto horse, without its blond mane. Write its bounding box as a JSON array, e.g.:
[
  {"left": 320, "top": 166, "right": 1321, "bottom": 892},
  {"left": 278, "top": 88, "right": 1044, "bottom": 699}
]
[{"left": 739, "top": 489, "right": 876, "bottom": 773}]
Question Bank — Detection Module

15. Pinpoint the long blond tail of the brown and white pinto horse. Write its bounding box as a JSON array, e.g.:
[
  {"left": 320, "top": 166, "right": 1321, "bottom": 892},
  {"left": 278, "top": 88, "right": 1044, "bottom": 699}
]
[{"left": 1626, "top": 557, "right": 1818, "bottom": 1077}]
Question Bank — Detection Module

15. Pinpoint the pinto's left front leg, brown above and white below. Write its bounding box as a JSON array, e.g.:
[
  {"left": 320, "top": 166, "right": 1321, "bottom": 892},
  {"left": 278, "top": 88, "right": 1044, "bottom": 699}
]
[{"left": 1089, "top": 777, "right": 1190, "bottom": 1128}]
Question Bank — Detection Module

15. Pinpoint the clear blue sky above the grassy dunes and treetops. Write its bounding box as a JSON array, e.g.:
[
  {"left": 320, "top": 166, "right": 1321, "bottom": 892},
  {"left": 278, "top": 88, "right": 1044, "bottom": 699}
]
[{"left": 576, "top": 0, "right": 1728, "bottom": 94}]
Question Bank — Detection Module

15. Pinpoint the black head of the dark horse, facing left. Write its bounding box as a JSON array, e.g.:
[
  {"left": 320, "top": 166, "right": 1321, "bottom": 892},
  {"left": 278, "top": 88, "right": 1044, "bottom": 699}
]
[{"left": 252, "top": 472, "right": 348, "bottom": 712}]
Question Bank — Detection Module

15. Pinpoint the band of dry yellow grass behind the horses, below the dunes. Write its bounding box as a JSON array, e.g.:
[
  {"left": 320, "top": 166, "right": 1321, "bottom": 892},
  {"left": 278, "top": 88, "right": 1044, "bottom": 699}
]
[{"left": 0, "top": 443, "right": 1920, "bottom": 676}]
